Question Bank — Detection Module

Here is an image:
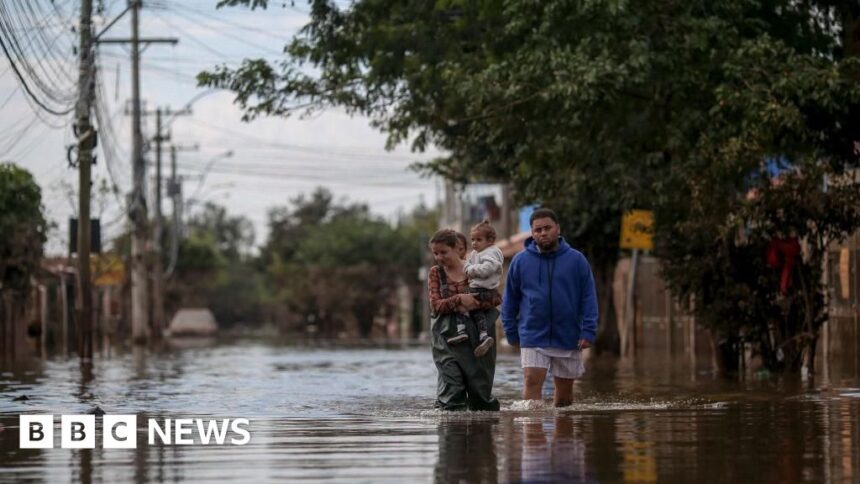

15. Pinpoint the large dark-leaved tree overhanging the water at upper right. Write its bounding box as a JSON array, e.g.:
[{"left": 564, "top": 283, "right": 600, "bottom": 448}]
[{"left": 199, "top": 0, "right": 860, "bottom": 369}]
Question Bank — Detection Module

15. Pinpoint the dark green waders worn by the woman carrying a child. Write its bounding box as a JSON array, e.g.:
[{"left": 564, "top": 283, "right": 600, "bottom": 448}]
[{"left": 431, "top": 267, "right": 499, "bottom": 411}]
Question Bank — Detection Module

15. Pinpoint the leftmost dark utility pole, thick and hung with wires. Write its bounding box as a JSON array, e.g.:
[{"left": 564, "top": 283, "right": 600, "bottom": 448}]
[{"left": 75, "top": 0, "right": 96, "bottom": 360}]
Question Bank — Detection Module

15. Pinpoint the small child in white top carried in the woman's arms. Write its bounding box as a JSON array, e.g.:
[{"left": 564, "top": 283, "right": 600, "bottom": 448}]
[{"left": 448, "top": 220, "right": 504, "bottom": 357}]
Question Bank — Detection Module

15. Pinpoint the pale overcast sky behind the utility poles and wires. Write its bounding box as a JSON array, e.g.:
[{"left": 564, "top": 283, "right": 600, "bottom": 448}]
[{"left": 0, "top": 0, "right": 439, "bottom": 254}]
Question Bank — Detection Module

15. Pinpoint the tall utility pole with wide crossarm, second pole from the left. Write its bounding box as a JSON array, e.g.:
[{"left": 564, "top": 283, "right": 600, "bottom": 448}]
[{"left": 99, "top": 0, "right": 178, "bottom": 344}]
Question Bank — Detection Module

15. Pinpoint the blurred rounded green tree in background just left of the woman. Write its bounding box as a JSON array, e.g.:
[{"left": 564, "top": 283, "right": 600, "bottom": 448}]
[{"left": 261, "top": 188, "right": 430, "bottom": 337}]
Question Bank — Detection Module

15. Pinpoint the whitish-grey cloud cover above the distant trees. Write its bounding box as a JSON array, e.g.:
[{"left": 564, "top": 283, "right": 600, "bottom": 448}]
[{"left": 0, "top": 1, "right": 438, "bottom": 253}]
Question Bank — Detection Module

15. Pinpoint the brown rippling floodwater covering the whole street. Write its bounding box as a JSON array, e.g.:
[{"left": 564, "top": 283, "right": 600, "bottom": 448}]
[{"left": 0, "top": 340, "right": 860, "bottom": 483}]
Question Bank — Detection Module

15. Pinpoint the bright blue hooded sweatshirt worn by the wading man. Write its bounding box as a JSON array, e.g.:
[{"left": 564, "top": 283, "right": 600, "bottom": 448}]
[{"left": 502, "top": 237, "right": 597, "bottom": 349}]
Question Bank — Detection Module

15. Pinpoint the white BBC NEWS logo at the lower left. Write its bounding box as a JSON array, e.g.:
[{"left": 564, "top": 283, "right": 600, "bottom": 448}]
[{"left": 18, "top": 415, "right": 251, "bottom": 449}]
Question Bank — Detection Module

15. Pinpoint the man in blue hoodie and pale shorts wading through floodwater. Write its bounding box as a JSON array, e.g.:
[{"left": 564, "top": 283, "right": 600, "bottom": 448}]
[{"left": 502, "top": 208, "right": 597, "bottom": 407}]
